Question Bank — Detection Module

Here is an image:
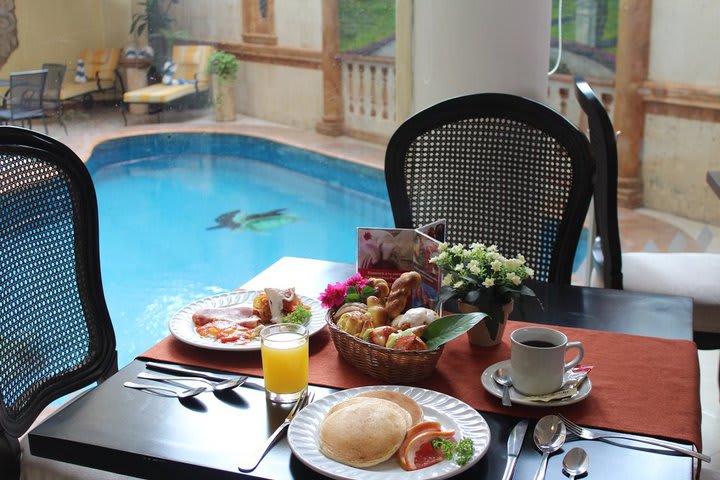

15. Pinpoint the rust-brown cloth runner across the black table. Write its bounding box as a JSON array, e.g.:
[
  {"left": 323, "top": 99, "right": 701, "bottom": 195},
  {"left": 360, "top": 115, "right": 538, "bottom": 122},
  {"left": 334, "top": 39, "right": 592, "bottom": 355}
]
[{"left": 139, "top": 321, "right": 702, "bottom": 450}]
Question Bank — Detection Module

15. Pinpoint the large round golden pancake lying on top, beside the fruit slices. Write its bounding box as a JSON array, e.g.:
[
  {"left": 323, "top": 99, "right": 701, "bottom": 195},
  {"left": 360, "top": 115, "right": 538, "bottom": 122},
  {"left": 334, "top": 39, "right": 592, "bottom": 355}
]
[{"left": 319, "top": 398, "right": 410, "bottom": 468}]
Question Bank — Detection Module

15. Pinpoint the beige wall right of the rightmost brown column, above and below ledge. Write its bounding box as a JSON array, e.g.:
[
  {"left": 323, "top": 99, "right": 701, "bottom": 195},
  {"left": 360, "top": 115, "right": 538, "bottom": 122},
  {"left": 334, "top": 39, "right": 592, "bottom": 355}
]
[{"left": 642, "top": 0, "right": 720, "bottom": 225}]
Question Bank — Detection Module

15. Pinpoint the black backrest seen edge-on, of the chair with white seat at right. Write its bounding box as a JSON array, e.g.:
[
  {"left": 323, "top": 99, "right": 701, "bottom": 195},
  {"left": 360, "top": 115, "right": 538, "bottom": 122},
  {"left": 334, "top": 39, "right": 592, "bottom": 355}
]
[{"left": 575, "top": 77, "right": 623, "bottom": 289}]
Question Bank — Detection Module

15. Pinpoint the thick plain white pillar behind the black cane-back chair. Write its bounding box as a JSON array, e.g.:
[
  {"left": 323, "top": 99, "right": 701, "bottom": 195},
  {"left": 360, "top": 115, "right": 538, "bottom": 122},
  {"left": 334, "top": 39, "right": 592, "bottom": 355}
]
[{"left": 408, "top": 0, "right": 552, "bottom": 114}]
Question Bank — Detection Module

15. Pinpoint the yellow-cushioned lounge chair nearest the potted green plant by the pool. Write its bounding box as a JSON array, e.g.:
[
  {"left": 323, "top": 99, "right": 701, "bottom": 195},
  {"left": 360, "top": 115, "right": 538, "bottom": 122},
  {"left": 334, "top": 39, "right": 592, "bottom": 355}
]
[{"left": 122, "top": 45, "right": 213, "bottom": 125}]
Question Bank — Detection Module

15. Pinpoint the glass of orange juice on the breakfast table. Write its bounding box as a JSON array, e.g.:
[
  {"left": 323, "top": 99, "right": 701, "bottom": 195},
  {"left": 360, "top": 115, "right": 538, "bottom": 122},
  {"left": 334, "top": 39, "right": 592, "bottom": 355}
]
[{"left": 260, "top": 323, "right": 309, "bottom": 403}]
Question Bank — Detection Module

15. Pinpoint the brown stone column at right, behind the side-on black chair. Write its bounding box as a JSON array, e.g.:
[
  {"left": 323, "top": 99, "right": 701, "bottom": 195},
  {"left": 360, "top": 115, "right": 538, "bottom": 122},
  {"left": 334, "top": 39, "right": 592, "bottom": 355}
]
[{"left": 613, "top": 0, "right": 652, "bottom": 208}]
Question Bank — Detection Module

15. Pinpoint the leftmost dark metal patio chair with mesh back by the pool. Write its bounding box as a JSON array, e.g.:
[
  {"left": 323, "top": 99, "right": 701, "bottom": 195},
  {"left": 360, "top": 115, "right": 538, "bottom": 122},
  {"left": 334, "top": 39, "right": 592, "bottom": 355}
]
[{"left": 0, "top": 70, "right": 48, "bottom": 134}]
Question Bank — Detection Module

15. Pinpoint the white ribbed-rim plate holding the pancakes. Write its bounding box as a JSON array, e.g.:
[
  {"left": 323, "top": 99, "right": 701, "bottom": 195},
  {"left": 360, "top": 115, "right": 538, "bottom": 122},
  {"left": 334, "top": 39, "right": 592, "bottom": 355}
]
[{"left": 288, "top": 385, "right": 490, "bottom": 480}]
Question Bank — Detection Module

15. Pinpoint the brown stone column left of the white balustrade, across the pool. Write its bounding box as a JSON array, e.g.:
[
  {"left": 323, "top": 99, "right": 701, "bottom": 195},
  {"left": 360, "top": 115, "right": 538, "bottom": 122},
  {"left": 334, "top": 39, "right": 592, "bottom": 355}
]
[{"left": 315, "top": 0, "right": 344, "bottom": 137}]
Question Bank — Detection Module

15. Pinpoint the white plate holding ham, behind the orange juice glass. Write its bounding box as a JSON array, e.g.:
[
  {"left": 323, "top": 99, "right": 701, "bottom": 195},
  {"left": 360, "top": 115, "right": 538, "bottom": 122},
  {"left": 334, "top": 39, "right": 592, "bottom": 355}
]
[{"left": 168, "top": 290, "right": 327, "bottom": 351}]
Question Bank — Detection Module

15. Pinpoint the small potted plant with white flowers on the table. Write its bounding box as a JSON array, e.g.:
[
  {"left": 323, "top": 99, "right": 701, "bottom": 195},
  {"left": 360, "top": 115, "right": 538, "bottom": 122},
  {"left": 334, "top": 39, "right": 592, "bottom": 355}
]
[{"left": 430, "top": 243, "right": 535, "bottom": 346}]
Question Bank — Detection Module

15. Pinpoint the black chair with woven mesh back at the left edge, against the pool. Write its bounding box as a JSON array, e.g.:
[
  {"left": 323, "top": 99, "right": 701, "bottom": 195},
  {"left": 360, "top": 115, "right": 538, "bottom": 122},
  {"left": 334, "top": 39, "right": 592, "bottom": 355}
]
[{"left": 0, "top": 126, "right": 118, "bottom": 479}]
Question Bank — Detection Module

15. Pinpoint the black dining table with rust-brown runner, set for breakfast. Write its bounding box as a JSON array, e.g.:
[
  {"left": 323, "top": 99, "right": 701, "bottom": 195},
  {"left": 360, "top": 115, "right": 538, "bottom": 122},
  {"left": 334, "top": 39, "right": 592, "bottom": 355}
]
[{"left": 28, "top": 257, "right": 702, "bottom": 480}]
